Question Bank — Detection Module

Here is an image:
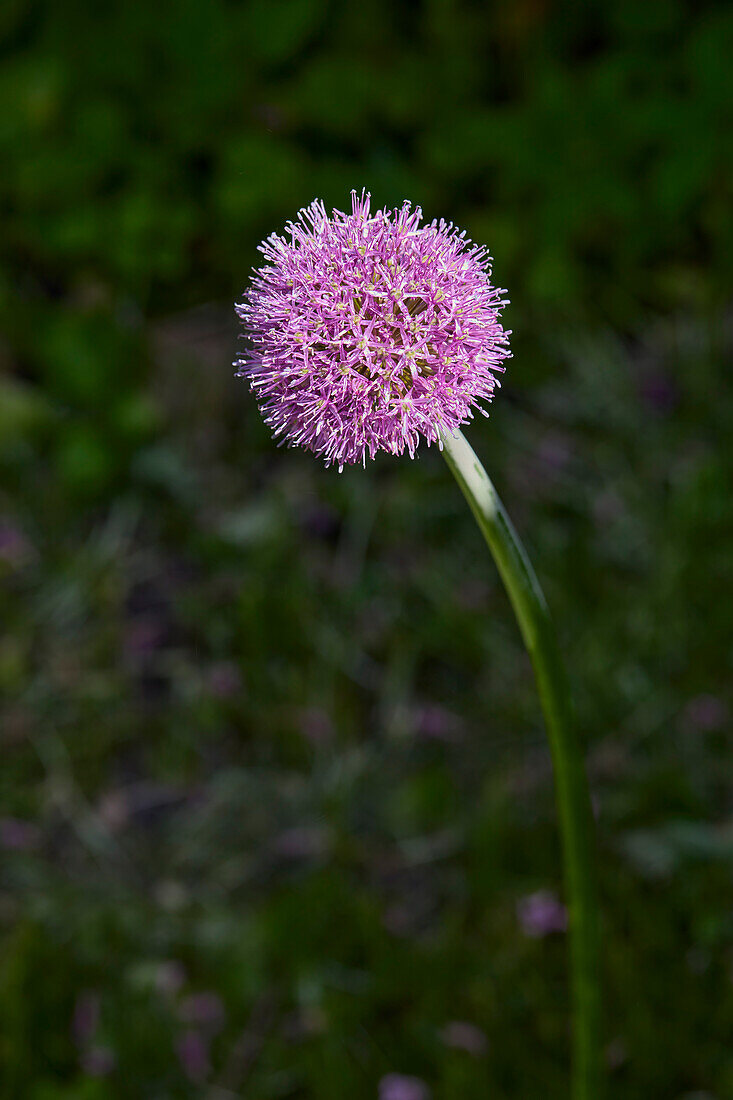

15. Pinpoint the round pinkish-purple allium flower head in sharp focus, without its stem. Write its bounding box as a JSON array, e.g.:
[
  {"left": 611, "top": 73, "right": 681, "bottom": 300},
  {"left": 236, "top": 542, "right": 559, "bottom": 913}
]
[{"left": 234, "top": 191, "right": 510, "bottom": 469}]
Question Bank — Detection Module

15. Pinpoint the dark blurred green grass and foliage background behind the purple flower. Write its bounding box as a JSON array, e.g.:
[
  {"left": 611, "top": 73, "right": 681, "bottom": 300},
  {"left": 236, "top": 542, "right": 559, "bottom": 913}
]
[{"left": 0, "top": 0, "right": 733, "bottom": 1100}]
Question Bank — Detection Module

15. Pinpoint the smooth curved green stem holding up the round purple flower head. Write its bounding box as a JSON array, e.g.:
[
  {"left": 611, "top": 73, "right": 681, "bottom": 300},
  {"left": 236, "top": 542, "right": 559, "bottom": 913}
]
[{"left": 441, "top": 431, "right": 601, "bottom": 1100}]
